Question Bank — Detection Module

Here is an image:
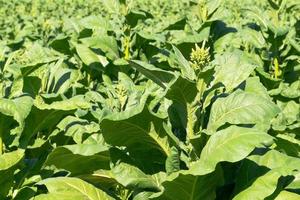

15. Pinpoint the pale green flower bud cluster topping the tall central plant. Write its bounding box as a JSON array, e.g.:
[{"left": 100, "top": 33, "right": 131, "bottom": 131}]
[{"left": 190, "top": 41, "right": 210, "bottom": 70}]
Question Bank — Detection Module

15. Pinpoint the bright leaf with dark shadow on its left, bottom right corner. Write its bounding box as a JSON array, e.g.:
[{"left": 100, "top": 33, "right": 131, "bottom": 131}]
[{"left": 234, "top": 150, "right": 300, "bottom": 199}]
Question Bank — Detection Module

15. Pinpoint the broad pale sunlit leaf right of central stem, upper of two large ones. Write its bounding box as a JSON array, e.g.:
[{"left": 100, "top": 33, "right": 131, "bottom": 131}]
[{"left": 208, "top": 91, "right": 279, "bottom": 131}]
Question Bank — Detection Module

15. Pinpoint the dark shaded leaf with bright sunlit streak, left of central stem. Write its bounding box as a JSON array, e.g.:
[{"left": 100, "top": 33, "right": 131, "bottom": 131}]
[{"left": 101, "top": 110, "right": 170, "bottom": 155}]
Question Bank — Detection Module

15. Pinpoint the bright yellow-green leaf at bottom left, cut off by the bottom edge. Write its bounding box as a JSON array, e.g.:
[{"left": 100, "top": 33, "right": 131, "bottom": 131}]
[{"left": 34, "top": 177, "right": 113, "bottom": 200}]
